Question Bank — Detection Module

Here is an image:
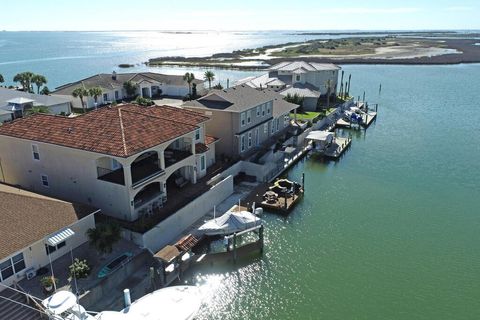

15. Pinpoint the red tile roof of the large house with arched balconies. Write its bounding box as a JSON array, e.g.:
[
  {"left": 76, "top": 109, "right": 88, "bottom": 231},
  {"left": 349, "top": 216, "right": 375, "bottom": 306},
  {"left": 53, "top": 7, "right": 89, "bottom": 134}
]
[{"left": 0, "top": 104, "right": 209, "bottom": 157}]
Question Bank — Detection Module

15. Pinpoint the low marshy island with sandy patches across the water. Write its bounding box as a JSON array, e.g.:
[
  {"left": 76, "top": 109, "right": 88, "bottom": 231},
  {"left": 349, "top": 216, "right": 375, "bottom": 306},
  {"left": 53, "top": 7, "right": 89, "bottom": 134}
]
[{"left": 146, "top": 32, "right": 480, "bottom": 71}]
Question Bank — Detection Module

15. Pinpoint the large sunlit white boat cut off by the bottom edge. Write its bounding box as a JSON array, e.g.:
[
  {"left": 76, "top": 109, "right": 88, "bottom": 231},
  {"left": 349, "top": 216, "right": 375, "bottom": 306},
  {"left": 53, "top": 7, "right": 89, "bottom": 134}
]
[{"left": 42, "top": 286, "right": 202, "bottom": 320}]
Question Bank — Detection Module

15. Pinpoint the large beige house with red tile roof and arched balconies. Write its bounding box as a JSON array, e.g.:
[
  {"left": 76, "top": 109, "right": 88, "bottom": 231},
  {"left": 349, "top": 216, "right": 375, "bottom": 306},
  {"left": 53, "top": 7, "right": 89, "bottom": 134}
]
[{"left": 0, "top": 104, "right": 217, "bottom": 221}]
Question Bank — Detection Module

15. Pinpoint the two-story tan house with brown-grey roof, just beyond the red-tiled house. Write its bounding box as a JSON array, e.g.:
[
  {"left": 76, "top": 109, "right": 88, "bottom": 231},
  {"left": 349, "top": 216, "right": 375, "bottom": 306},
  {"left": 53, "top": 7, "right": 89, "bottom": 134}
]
[{"left": 183, "top": 85, "right": 298, "bottom": 158}]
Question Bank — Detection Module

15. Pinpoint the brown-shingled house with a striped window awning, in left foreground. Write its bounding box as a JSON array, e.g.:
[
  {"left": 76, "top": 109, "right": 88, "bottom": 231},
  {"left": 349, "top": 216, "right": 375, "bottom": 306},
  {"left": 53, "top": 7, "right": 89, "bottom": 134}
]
[{"left": 0, "top": 184, "right": 99, "bottom": 291}]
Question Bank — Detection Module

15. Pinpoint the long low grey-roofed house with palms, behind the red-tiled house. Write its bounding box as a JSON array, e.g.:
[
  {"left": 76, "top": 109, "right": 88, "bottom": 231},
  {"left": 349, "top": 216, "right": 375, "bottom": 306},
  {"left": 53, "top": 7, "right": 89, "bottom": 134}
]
[{"left": 52, "top": 72, "right": 206, "bottom": 108}]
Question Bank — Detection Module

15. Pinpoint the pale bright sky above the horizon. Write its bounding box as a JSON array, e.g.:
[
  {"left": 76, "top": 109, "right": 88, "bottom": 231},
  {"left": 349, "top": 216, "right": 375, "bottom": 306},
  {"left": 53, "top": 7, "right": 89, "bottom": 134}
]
[{"left": 0, "top": 0, "right": 480, "bottom": 31}]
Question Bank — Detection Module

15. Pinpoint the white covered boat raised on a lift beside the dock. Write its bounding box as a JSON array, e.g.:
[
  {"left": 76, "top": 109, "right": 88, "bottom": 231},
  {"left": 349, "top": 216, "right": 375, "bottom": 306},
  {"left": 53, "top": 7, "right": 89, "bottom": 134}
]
[{"left": 198, "top": 209, "right": 262, "bottom": 236}]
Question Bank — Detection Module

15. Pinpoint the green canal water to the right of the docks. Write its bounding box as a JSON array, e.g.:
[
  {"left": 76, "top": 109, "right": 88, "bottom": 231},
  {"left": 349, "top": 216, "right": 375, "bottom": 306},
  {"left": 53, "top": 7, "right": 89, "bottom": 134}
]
[{"left": 192, "top": 65, "right": 480, "bottom": 320}]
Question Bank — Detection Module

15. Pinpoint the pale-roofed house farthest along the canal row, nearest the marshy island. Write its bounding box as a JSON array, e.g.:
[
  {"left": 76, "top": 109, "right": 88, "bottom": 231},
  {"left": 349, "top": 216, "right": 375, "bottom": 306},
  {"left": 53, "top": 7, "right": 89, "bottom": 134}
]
[{"left": 237, "top": 61, "right": 341, "bottom": 111}]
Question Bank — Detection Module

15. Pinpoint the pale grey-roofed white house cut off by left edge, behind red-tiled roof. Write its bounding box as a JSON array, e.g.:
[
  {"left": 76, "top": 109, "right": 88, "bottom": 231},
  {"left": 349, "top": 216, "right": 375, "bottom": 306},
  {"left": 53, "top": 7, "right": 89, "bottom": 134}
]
[{"left": 0, "top": 88, "right": 73, "bottom": 123}]
